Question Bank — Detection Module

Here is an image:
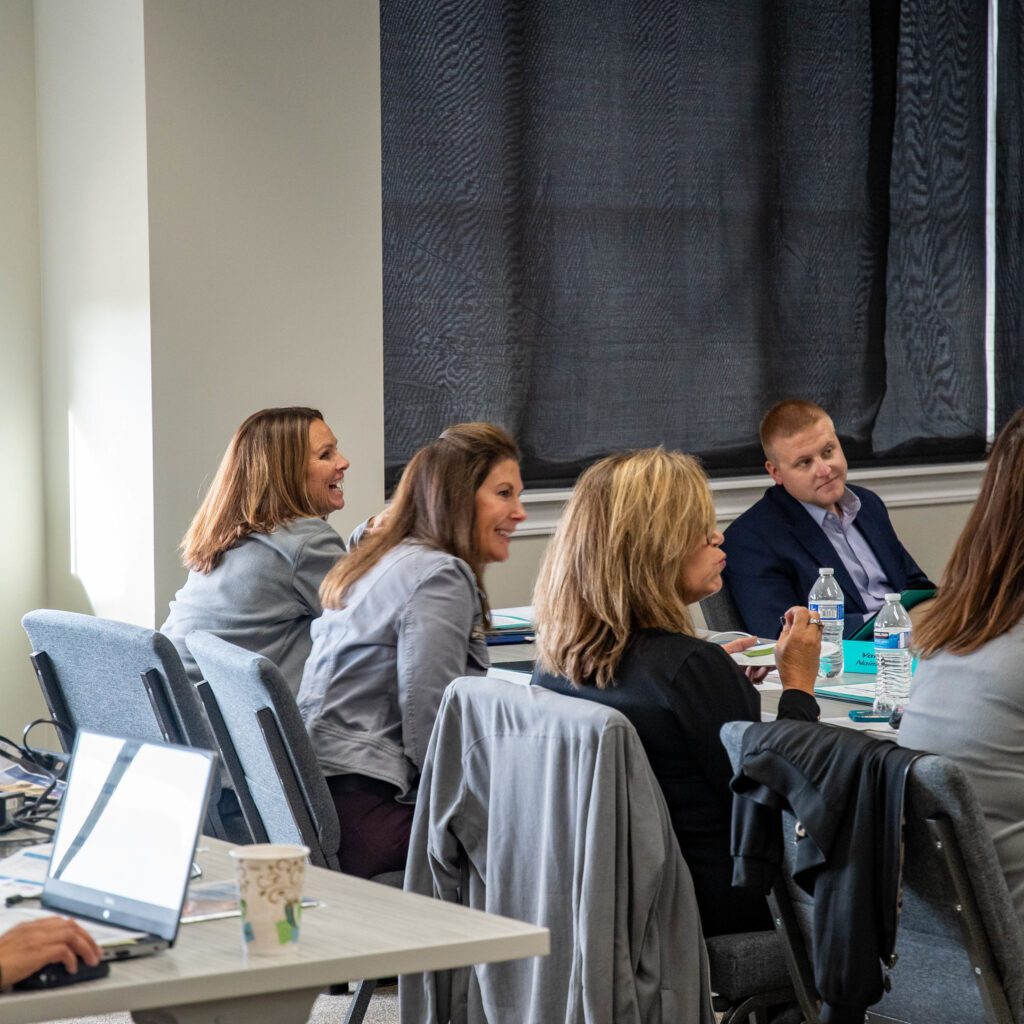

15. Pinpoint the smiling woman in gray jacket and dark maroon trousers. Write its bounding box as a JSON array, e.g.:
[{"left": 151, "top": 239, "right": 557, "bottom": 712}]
[{"left": 298, "top": 423, "right": 525, "bottom": 878}]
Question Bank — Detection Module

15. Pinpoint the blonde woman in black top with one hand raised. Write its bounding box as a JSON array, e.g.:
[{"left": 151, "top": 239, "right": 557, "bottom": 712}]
[{"left": 534, "top": 449, "right": 821, "bottom": 935}]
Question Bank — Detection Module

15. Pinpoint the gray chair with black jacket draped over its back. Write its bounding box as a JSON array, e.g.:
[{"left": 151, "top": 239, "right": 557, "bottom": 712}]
[{"left": 722, "top": 722, "right": 1024, "bottom": 1024}]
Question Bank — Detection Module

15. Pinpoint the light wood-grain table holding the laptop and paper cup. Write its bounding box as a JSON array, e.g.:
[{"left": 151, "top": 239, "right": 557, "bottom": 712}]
[{"left": 0, "top": 836, "right": 549, "bottom": 1024}]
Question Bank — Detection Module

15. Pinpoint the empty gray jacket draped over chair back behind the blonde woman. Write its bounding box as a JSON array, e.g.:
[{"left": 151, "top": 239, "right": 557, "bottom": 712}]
[{"left": 398, "top": 679, "right": 715, "bottom": 1024}]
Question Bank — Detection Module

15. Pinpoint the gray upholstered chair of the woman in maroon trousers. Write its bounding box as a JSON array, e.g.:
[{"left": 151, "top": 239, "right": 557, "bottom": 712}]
[{"left": 185, "top": 630, "right": 402, "bottom": 1024}]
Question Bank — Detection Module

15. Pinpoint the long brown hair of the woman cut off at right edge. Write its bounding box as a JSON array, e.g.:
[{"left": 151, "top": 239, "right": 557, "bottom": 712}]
[{"left": 913, "top": 409, "right": 1024, "bottom": 657}]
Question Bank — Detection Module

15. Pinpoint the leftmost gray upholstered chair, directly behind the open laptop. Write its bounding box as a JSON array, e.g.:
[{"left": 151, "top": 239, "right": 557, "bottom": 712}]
[{"left": 22, "top": 608, "right": 244, "bottom": 843}]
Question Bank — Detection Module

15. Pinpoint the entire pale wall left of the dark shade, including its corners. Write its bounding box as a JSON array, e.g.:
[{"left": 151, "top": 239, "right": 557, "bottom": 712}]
[{"left": 0, "top": 0, "right": 384, "bottom": 731}]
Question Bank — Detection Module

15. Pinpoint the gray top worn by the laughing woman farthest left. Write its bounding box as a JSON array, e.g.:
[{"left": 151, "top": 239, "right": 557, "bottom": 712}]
[{"left": 160, "top": 518, "right": 345, "bottom": 693}]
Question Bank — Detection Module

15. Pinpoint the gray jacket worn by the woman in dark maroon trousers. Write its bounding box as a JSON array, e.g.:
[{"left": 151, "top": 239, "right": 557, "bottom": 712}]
[{"left": 298, "top": 541, "right": 489, "bottom": 802}]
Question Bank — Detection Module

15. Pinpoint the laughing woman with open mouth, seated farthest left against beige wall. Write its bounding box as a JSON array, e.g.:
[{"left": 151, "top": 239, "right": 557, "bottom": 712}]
[{"left": 161, "top": 407, "right": 348, "bottom": 692}]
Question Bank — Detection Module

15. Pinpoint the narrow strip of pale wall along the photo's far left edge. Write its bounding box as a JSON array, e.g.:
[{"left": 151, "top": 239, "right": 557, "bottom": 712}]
[{"left": 0, "top": 0, "right": 45, "bottom": 738}]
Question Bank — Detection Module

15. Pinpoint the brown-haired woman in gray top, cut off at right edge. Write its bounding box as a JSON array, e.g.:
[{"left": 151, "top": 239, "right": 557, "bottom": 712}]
[{"left": 899, "top": 409, "right": 1024, "bottom": 922}]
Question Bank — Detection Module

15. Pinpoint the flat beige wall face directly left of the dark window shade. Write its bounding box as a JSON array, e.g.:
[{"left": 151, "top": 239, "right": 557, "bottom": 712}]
[{"left": 145, "top": 0, "right": 384, "bottom": 624}]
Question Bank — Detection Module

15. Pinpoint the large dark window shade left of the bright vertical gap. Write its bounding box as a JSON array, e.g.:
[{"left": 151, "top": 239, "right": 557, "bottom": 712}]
[{"left": 381, "top": 0, "right": 986, "bottom": 486}]
